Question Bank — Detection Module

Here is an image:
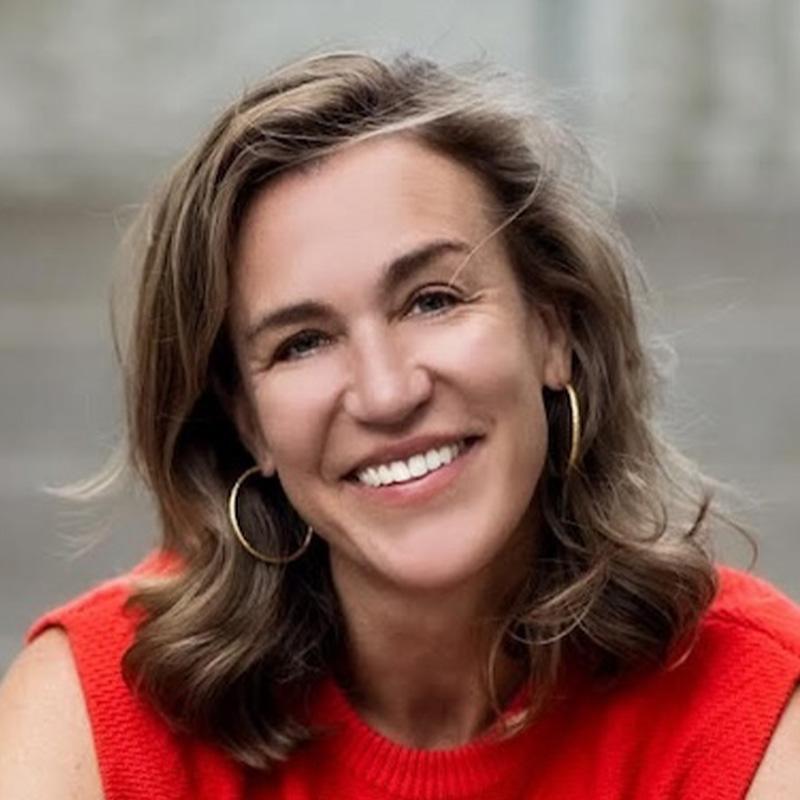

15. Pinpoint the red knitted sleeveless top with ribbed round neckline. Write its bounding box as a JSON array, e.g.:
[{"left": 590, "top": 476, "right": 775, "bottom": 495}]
[{"left": 29, "top": 568, "right": 800, "bottom": 800}]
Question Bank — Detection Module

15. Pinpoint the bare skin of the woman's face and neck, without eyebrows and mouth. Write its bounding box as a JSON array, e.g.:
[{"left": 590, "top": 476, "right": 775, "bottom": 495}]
[{"left": 233, "top": 137, "right": 570, "bottom": 747}]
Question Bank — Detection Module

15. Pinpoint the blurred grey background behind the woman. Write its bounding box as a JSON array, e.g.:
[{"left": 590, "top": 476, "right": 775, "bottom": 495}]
[{"left": 0, "top": 0, "right": 800, "bottom": 670}]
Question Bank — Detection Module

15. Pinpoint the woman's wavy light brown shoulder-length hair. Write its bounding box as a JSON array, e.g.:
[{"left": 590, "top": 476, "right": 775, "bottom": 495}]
[{"left": 106, "top": 54, "right": 715, "bottom": 768}]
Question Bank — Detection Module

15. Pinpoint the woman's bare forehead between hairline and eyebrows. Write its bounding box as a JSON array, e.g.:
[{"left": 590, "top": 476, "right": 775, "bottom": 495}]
[{"left": 235, "top": 136, "right": 504, "bottom": 296}]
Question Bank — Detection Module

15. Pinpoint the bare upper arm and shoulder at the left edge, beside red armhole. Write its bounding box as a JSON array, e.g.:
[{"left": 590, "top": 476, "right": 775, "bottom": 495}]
[{"left": 0, "top": 629, "right": 103, "bottom": 800}]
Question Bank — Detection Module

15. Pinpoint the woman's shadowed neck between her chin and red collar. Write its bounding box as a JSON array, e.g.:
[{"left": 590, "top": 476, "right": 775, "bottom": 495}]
[{"left": 332, "top": 532, "right": 524, "bottom": 749}]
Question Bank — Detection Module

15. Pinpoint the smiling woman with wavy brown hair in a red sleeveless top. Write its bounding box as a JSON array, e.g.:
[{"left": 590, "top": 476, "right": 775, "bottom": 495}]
[{"left": 0, "top": 54, "right": 800, "bottom": 800}]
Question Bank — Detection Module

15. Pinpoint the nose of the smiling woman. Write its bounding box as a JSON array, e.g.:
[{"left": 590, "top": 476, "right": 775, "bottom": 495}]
[{"left": 344, "top": 324, "right": 433, "bottom": 425}]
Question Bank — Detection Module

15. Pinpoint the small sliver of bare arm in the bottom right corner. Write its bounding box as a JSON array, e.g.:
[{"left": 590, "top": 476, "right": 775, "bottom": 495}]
[{"left": 747, "top": 686, "right": 800, "bottom": 800}]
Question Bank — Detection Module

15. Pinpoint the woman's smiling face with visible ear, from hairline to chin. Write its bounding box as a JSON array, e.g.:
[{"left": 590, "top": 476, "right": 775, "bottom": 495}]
[{"left": 232, "top": 136, "right": 569, "bottom": 589}]
